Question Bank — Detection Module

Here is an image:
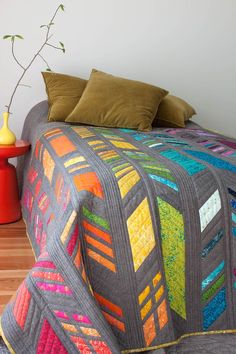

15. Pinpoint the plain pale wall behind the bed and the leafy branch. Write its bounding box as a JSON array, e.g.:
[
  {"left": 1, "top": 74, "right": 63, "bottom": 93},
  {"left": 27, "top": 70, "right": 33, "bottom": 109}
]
[{"left": 0, "top": 0, "right": 236, "bottom": 137}]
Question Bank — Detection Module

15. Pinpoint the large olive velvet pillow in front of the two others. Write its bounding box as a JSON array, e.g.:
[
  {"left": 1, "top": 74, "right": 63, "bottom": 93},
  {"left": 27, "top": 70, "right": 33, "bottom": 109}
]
[{"left": 66, "top": 69, "right": 168, "bottom": 131}]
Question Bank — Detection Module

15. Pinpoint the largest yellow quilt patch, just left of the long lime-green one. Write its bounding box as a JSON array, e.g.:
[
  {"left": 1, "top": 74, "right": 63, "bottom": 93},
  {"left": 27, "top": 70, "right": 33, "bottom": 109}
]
[{"left": 127, "top": 198, "right": 156, "bottom": 272}]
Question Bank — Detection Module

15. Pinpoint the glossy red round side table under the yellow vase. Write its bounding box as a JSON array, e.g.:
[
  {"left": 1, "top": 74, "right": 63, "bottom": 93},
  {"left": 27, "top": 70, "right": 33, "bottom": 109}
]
[{"left": 0, "top": 140, "right": 30, "bottom": 224}]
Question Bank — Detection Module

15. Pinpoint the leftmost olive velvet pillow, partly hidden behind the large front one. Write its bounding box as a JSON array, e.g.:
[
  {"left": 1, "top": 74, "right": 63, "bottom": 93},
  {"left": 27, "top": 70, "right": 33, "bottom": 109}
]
[{"left": 42, "top": 72, "right": 87, "bottom": 121}]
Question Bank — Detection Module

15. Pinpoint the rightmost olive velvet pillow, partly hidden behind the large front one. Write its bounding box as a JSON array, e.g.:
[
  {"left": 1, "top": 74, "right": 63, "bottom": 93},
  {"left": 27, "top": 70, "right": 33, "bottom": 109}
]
[{"left": 152, "top": 95, "right": 196, "bottom": 128}]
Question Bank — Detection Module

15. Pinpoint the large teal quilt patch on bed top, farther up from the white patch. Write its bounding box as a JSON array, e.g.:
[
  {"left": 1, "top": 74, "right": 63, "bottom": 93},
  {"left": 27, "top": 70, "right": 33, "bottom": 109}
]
[{"left": 160, "top": 150, "right": 206, "bottom": 176}]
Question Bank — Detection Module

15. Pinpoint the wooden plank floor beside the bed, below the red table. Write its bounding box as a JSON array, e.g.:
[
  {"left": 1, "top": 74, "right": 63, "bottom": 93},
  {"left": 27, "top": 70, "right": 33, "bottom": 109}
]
[{"left": 0, "top": 220, "right": 35, "bottom": 315}]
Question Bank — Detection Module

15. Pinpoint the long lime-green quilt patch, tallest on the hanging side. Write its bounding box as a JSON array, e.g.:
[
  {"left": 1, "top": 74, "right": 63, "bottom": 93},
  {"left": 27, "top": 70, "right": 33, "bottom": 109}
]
[{"left": 157, "top": 198, "right": 186, "bottom": 319}]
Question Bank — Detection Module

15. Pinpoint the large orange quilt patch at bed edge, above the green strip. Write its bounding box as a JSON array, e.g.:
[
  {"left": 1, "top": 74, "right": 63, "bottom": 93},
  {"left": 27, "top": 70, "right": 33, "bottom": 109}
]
[{"left": 73, "top": 172, "right": 103, "bottom": 198}]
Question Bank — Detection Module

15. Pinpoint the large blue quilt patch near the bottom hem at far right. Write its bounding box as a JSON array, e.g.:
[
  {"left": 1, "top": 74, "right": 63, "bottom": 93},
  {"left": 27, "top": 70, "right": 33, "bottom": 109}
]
[{"left": 203, "top": 288, "right": 226, "bottom": 331}]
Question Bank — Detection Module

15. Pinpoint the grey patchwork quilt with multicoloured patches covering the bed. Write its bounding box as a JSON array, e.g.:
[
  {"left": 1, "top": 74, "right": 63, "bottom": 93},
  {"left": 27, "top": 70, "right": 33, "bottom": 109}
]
[{"left": 1, "top": 101, "right": 236, "bottom": 354}]
